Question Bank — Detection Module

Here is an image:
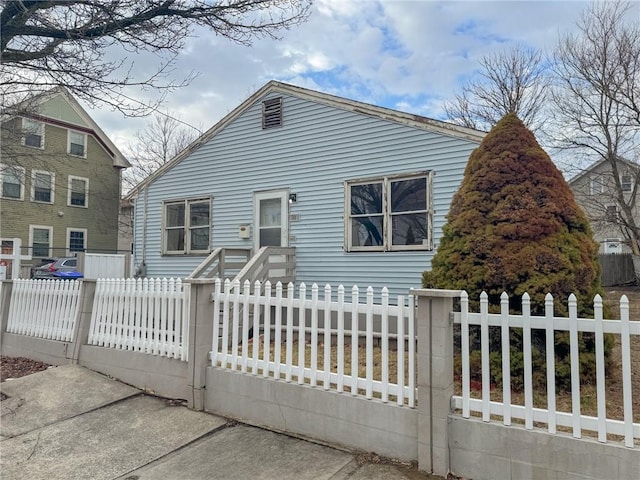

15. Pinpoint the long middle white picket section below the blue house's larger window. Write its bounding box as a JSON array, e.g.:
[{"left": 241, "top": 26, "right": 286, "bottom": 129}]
[{"left": 211, "top": 279, "right": 416, "bottom": 407}]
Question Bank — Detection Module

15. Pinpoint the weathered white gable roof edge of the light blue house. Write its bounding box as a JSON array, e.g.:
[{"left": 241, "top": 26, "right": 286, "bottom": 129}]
[{"left": 125, "top": 80, "right": 486, "bottom": 199}]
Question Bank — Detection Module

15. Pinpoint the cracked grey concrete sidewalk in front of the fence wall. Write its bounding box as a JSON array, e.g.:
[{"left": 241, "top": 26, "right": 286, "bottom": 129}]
[{"left": 0, "top": 365, "right": 440, "bottom": 480}]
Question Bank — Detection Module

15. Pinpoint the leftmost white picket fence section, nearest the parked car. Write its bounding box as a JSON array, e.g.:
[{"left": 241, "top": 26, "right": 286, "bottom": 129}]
[{"left": 7, "top": 280, "right": 82, "bottom": 342}]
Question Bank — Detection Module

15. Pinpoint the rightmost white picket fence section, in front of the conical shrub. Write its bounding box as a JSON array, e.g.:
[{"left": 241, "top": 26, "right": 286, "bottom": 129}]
[{"left": 454, "top": 292, "right": 640, "bottom": 447}]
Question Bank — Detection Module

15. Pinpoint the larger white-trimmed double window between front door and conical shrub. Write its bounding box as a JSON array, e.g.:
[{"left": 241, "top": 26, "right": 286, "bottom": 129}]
[{"left": 345, "top": 172, "right": 433, "bottom": 252}]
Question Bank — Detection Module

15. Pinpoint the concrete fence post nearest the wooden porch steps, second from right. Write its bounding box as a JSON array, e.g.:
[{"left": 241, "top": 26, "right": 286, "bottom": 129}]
[{"left": 183, "top": 278, "right": 215, "bottom": 411}]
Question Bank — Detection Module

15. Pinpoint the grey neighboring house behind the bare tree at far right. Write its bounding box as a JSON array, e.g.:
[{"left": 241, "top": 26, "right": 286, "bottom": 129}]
[{"left": 569, "top": 160, "right": 640, "bottom": 253}]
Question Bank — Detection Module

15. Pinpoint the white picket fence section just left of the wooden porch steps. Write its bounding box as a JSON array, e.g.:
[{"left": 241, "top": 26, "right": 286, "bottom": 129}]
[{"left": 89, "top": 278, "right": 190, "bottom": 361}]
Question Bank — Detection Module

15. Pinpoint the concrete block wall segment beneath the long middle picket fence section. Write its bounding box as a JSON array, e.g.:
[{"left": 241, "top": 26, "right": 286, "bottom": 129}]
[{"left": 205, "top": 367, "right": 418, "bottom": 460}]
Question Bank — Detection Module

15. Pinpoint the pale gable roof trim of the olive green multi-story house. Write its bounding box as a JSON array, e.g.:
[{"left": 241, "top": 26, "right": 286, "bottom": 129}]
[{"left": 2, "top": 87, "right": 131, "bottom": 168}]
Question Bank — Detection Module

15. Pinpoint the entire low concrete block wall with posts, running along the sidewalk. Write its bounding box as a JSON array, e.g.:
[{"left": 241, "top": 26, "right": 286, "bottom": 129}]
[{"left": 0, "top": 280, "right": 640, "bottom": 480}]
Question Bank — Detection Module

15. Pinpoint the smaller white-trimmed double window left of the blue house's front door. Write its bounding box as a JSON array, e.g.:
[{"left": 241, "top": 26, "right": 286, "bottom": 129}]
[{"left": 162, "top": 198, "right": 211, "bottom": 255}]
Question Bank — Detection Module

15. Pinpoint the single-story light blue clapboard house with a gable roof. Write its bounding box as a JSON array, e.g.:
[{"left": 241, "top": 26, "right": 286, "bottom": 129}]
[{"left": 129, "top": 81, "right": 484, "bottom": 294}]
